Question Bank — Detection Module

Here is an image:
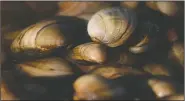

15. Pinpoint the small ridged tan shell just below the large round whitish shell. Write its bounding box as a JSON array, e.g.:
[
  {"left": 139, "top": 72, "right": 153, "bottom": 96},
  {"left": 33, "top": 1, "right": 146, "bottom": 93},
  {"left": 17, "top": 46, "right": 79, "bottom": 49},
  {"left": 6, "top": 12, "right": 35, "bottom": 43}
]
[{"left": 69, "top": 42, "right": 107, "bottom": 64}]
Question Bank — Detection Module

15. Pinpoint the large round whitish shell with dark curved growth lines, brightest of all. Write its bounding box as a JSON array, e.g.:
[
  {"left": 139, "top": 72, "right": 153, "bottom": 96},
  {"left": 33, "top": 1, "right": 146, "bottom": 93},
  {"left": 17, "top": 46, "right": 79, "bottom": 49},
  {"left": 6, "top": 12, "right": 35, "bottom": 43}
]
[{"left": 87, "top": 7, "right": 136, "bottom": 47}]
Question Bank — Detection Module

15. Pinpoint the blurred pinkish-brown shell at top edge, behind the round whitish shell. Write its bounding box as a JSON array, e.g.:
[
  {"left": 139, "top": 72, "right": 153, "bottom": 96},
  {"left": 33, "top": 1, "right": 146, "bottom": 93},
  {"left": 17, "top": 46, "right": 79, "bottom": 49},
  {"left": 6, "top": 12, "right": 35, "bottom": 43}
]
[{"left": 57, "top": 1, "right": 111, "bottom": 20}]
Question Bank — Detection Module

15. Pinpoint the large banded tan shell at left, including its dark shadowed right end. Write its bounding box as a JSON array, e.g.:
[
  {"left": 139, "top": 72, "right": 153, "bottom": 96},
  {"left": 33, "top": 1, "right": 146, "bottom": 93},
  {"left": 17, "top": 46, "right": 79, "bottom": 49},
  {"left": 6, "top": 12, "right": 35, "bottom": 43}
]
[{"left": 11, "top": 17, "right": 88, "bottom": 57}]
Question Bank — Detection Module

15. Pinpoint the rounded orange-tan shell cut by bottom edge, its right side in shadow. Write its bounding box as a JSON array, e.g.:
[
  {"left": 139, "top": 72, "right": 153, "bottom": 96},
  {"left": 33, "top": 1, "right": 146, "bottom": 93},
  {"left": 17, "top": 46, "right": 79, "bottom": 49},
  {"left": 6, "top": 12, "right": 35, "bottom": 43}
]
[{"left": 73, "top": 74, "right": 132, "bottom": 100}]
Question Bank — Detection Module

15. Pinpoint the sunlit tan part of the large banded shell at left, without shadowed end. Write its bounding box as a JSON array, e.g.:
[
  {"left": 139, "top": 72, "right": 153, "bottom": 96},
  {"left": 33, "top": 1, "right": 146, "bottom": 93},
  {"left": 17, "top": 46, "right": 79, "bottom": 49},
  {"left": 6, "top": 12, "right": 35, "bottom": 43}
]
[{"left": 11, "top": 20, "right": 71, "bottom": 55}]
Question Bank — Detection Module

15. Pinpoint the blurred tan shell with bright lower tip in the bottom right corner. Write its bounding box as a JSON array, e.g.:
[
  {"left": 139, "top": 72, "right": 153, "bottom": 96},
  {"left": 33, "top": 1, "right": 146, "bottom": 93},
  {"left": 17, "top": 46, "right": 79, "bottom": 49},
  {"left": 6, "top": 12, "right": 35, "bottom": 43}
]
[{"left": 148, "top": 76, "right": 183, "bottom": 98}]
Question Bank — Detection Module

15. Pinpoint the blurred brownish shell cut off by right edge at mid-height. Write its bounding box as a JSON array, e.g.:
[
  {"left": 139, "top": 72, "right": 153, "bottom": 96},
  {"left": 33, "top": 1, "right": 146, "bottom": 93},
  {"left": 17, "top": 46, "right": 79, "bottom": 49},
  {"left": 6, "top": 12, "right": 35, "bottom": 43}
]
[{"left": 169, "top": 42, "right": 184, "bottom": 67}]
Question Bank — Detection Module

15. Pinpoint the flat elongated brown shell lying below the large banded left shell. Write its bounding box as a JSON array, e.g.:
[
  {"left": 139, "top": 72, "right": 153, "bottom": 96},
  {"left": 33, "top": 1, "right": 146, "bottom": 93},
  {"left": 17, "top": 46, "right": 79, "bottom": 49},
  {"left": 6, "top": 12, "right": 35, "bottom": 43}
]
[{"left": 16, "top": 57, "right": 74, "bottom": 77}]
